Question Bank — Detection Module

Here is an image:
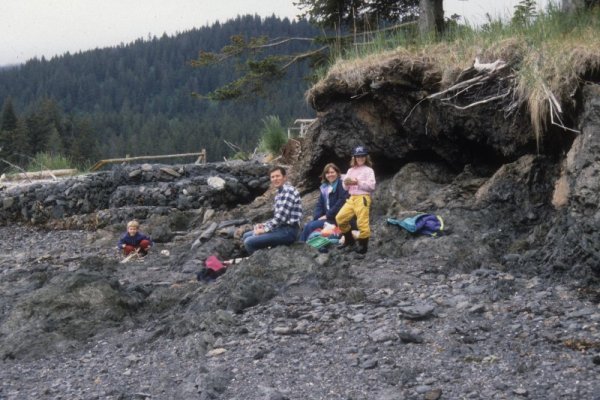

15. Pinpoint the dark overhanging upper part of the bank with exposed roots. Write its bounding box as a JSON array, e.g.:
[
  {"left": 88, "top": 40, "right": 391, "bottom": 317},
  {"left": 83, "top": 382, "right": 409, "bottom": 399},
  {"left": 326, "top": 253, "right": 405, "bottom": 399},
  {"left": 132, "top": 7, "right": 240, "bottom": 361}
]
[{"left": 303, "top": 56, "right": 552, "bottom": 183}]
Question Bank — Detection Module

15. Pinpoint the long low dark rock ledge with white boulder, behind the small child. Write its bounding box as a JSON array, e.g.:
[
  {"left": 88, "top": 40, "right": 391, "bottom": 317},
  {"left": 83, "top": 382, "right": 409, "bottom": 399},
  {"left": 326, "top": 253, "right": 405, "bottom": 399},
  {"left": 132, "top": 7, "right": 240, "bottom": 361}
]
[{"left": 0, "top": 162, "right": 269, "bottom": 228}]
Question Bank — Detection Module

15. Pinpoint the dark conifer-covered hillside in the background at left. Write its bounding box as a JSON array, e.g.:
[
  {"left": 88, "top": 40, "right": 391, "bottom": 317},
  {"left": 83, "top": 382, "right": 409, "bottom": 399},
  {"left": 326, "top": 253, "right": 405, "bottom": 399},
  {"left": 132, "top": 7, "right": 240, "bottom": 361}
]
[{"left": 0, "top": 15, "right": 318, "bottom": 170}]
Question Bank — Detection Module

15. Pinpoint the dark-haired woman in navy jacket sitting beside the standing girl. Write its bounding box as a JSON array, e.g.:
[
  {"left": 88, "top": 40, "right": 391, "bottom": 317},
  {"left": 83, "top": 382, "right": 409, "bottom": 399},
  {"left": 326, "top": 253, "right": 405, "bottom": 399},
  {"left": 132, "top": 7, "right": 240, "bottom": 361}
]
[{"left": 300, "top": 163, "right": 348, "bottom": 242}]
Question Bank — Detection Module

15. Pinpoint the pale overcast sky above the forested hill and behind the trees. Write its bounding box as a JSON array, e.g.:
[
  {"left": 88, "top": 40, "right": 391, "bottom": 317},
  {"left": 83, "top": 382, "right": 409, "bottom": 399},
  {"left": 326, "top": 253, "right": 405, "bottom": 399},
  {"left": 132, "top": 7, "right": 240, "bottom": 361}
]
[{"left": 0, "top": 0, "right": 548, "bottom": 65}]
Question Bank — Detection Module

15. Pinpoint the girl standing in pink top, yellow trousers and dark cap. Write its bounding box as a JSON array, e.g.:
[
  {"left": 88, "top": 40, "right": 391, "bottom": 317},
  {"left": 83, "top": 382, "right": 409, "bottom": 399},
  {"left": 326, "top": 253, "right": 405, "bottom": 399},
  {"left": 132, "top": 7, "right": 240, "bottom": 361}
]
[{"left": 335, "top": 146, "right": 375, "bottom": 254}]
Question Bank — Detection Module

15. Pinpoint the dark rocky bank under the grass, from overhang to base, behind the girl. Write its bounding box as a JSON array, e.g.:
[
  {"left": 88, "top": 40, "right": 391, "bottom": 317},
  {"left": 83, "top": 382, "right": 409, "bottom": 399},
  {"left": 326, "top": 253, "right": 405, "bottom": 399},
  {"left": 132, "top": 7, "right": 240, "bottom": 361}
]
[{"left": 299, "top": 55, "right": 600, "bottom": 278}]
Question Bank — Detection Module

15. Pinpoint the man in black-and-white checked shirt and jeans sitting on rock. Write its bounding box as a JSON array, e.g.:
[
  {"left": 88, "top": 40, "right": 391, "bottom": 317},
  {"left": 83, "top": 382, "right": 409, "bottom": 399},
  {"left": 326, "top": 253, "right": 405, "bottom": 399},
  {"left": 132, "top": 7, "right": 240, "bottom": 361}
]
[{"left": 242, "top": 167, "right": 302, "bottom": 254}]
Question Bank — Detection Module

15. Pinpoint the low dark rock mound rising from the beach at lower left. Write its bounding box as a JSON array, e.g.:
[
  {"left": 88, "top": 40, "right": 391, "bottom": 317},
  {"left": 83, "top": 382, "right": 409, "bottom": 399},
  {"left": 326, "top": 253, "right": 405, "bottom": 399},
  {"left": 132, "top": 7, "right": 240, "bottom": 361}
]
[{"left": 0, "top": 258, "right": 145, "bottom": 359}]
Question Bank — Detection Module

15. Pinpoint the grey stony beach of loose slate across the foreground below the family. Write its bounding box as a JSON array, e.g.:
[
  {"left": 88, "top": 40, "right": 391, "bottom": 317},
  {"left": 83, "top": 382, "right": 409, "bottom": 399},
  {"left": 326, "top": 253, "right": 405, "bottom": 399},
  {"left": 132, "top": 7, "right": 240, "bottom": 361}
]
[{"left": 0, "top": 220, "right": 600, "bottom": 400}]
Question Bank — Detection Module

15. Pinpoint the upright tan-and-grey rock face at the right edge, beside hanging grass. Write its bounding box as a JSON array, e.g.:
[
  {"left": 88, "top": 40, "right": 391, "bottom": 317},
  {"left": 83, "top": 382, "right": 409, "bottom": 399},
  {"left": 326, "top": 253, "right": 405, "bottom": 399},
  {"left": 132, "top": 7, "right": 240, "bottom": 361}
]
[{"left": 527, "top": 85, "right": 600, "bottom": 278}]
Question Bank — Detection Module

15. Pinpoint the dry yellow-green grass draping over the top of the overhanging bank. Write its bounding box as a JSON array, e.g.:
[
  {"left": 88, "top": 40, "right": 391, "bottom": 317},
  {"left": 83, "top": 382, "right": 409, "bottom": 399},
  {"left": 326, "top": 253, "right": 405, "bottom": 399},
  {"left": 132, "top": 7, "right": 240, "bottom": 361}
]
[{"left": 317, "top": 4, "right": 600, "bottom": 139}]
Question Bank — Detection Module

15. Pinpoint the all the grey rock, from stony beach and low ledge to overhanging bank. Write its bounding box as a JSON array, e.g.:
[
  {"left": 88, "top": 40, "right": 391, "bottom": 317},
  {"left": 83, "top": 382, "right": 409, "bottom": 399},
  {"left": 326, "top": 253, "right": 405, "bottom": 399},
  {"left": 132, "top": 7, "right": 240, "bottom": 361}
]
[{"left": 0, "top": 45, "right": 600, "bottom": 400}]
